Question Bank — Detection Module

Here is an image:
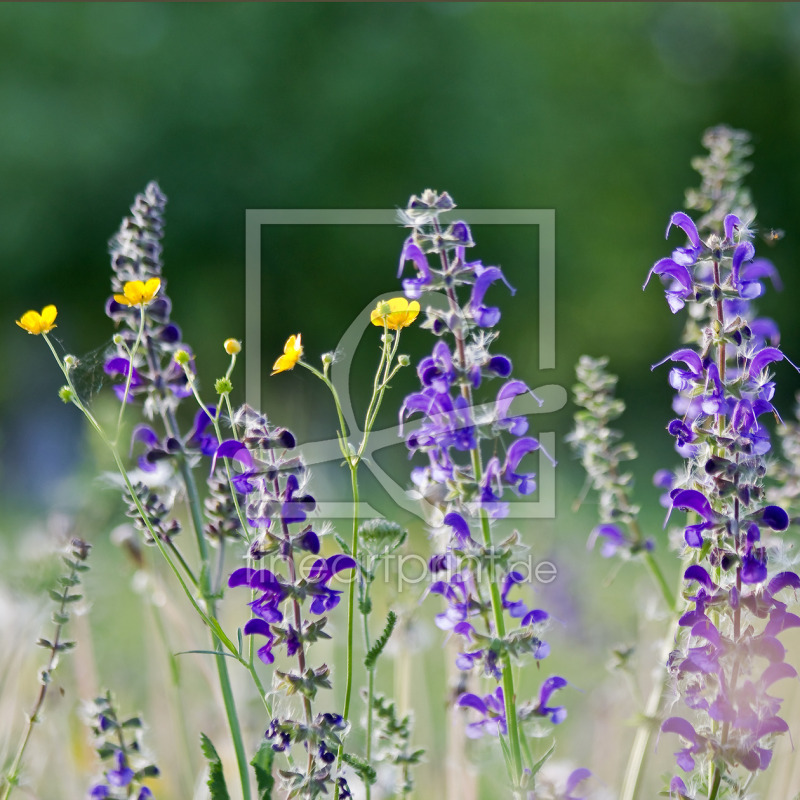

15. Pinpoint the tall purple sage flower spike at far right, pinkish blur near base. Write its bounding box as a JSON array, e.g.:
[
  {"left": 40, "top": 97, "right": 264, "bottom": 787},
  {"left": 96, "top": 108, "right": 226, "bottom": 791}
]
[{"left": 648, "top": 200, "right": 800, "bottom": 796}]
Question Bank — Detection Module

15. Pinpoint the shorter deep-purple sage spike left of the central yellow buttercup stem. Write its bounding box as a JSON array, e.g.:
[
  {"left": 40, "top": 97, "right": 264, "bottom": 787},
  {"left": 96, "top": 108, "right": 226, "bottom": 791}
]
[{"left": 220, "top": 406, "right": 356, "bottom": 798}]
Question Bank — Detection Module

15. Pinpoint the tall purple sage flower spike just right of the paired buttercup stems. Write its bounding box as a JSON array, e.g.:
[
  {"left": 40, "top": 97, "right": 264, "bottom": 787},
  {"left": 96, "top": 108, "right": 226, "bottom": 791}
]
[{"left": 399, "top": 190, "right": 567, "bottom": 785}]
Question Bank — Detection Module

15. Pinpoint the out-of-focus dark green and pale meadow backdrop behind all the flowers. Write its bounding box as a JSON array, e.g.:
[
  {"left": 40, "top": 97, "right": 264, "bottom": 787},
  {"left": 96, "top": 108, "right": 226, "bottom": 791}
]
[{"left": 0, "top": 3, "right": 800, "bottom": 800}]
